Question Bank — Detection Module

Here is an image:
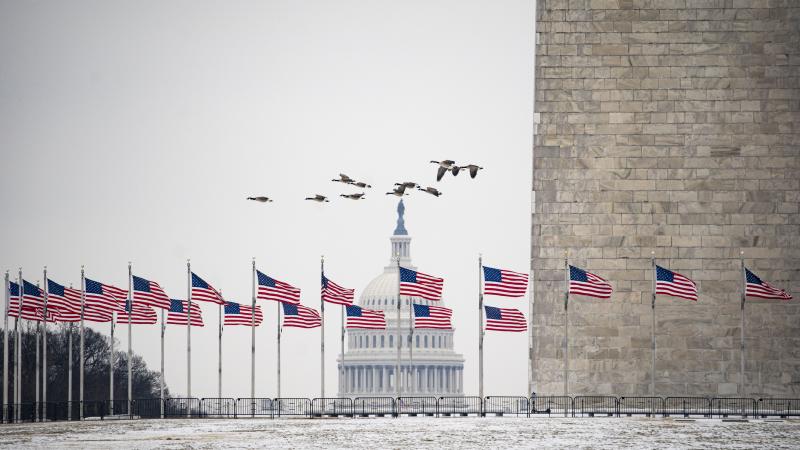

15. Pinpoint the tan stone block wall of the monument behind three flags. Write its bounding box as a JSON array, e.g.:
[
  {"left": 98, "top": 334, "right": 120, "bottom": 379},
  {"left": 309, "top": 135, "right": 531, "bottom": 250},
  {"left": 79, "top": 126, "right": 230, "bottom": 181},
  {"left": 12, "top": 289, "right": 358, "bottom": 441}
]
[{"left": 531, "top": 0, "right": 800, "bottom": 397}]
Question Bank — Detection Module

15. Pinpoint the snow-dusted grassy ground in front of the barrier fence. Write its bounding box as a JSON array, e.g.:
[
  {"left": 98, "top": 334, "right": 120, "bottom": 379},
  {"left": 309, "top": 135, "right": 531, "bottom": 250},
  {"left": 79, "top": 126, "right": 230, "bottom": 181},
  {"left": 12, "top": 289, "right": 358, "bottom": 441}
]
[{"left": 0, "top": 417, "right": 800, "bottom": 449}]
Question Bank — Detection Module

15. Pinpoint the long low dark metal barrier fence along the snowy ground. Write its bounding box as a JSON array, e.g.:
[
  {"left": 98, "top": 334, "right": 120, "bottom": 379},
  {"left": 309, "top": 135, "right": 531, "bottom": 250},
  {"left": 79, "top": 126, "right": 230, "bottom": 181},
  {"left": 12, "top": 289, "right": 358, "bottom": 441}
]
[{"left": 0, "top": 396, "right": 800, "bottom": 423}]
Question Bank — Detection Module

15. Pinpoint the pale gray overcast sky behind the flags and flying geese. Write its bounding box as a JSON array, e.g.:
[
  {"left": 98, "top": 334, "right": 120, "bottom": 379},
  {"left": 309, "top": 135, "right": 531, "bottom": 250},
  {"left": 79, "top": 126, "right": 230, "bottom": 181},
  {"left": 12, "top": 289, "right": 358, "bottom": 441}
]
[{"left": 0, "top": 0, "right": 534, "bottom": 397}]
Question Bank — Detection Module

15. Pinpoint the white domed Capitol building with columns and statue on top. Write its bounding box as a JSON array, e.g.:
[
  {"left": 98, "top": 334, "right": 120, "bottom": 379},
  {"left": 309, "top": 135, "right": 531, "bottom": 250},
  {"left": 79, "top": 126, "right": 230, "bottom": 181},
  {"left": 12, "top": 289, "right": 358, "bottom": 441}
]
[{"left": 339, "top": 200, "right": 464, "bottom": 397}]
